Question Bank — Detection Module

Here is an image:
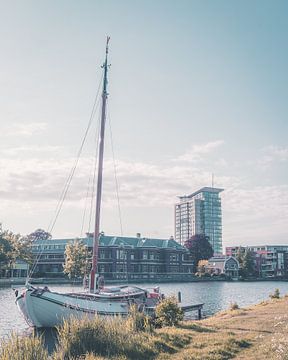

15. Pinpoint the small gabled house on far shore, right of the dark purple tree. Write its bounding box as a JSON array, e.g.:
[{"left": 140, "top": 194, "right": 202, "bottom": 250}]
[{"left": 206, "top": 256, "right": 239, "bottom": 280}]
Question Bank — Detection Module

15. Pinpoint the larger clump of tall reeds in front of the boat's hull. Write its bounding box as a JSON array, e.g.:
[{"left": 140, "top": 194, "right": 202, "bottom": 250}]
[{"left": 53, "top": 317, "right": 158, "bottom": 360}]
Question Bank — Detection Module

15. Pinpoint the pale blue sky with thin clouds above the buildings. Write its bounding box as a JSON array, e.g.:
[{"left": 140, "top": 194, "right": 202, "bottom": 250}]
[{"left": 0, "top": 0, "right": 288, "bottom": 248}]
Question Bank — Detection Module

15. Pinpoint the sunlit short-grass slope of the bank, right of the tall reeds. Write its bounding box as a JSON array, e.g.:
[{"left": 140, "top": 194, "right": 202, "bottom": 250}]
[{"left": 164, "top": 296, "right": 288, "bottom": 360}]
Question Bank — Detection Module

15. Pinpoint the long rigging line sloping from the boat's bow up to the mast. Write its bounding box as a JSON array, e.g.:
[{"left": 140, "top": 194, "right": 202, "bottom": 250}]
[{"left": 28, "top": 74, "right": 103, "bottom": 280}]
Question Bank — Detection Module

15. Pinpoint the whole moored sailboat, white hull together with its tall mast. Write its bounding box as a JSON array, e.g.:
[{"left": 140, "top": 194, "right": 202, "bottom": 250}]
[{"left": 16, "top": 37, "right": 161, "bottom": 328}]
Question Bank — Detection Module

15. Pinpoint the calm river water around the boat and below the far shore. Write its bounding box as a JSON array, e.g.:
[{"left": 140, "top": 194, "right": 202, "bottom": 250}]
[{"left": 0, "top": 281, "right": 288, "bottom": 338}]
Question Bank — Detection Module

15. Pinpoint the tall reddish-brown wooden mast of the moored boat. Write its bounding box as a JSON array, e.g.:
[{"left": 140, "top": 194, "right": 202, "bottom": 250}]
[{"left": 90, "top": 36, "right": 110, "bottom": 292}]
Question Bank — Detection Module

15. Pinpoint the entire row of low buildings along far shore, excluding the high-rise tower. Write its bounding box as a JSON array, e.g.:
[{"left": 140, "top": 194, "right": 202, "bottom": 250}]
[{"left": 5, "top": 234, "right": 288, "bottom": 282}]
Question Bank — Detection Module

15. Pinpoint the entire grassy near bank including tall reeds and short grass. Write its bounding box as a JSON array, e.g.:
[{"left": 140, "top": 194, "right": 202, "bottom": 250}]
[{"left": 0, "top": 297, "right": 288, "bottom": 360}]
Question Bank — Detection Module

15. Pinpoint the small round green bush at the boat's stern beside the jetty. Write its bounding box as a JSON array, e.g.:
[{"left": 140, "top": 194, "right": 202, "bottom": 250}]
[{"left": 155, "top": 296, "right": 184, "bottom": 327}]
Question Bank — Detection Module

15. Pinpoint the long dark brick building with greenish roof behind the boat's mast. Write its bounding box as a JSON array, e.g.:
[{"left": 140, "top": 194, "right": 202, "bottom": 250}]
[{"left": 32, "top": 235, "right": 193, "bottom": 282}]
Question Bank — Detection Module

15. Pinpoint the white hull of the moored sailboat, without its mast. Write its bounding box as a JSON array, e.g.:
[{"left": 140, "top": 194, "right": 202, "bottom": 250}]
[{"left": 16, "top": 287, "right": 158, "bottom": 328}]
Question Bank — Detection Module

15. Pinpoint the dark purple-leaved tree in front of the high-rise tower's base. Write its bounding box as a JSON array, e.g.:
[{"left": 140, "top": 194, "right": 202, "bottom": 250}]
[{"left": 184, "top": 234, "right": 213, "bottom": 273}]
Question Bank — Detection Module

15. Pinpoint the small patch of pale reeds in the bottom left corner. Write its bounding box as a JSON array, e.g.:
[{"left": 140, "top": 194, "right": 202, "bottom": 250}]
[{"left": 0, "top": 334, "right": 48, "bottom": 360}]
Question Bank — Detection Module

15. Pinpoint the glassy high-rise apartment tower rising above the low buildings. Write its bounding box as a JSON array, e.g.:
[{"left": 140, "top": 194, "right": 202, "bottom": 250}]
[{"left": 175, "top": 187, "right": 223, "bottom": 254}]
